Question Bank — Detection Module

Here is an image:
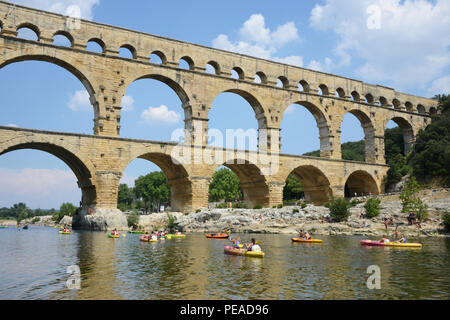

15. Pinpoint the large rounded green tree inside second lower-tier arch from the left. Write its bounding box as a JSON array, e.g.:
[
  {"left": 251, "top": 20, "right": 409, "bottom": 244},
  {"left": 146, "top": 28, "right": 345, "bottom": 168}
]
[{"left": 134, "top": 171, "right": 170, "bottom": 210}]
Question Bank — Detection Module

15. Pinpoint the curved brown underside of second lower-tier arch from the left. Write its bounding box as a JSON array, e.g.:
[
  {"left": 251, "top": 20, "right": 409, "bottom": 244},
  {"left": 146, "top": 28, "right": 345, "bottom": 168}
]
[{"left": 121, "top": 151, "right": 193, "bottom": 211}]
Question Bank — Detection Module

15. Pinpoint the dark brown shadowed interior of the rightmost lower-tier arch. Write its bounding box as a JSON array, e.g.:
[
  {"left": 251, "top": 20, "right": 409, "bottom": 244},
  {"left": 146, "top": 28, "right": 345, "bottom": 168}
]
[{"left": 344, "top": 170, "right": 380, "bottom": 198}]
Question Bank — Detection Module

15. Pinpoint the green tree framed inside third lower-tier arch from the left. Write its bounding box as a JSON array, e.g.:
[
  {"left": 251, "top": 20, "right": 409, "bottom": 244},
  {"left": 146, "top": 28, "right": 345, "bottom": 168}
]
[{"left": 209, "top": 168, "right": 242, "bottom": 202}]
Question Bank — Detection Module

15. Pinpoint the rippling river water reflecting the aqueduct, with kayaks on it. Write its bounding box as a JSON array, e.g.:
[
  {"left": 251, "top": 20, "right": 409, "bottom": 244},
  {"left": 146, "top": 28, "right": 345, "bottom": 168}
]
[{"left": 0, "top": 226, "right": 450, "bottom": 300}]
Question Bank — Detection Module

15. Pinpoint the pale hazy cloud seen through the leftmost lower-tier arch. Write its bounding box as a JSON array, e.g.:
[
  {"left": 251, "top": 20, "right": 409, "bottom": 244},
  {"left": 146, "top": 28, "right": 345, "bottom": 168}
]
[{"left": 0, "top": 168, "right": 81, "bottom": 209}]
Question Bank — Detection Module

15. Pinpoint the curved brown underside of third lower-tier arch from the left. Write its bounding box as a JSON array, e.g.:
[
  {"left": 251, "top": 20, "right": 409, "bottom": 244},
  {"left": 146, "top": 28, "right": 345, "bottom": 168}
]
[{"left": 209, "top": 158, "right": 270, "bottom": 207}]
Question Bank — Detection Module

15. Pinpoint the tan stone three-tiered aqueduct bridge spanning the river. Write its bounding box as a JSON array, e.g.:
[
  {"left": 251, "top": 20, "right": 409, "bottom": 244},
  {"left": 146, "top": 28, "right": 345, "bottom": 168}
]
[{"left": 0, "top": 2, "right": 437, "bottom": 211}]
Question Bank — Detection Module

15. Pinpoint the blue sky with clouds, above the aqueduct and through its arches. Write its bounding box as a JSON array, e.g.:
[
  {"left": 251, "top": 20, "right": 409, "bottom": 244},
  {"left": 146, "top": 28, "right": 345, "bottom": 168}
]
[{"left": 0, "top": 0, "right": 450, "bottom": 208}]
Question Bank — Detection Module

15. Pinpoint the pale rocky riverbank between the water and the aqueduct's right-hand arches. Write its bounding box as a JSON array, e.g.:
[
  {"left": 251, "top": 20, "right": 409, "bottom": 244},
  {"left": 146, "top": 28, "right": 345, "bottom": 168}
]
[{"left": 136, "top": 190, "right": 450, "bottom": 237}]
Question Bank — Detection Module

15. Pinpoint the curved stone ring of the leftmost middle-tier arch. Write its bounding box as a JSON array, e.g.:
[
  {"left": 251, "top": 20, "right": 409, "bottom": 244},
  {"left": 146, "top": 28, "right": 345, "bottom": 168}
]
[{"left": 0, "top": 52, "right": 100, "bottom": 118}]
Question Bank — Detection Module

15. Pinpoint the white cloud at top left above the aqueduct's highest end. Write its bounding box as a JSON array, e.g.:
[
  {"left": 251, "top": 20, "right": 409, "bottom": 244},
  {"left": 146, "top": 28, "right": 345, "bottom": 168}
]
[{"left": 10, "top": 0, "right": 100, "bottom": 20}]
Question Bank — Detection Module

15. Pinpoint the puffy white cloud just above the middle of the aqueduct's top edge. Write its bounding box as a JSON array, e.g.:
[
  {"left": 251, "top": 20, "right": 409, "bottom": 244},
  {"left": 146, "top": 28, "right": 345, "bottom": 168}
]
[{"left": 213, "top": 14, "right": 303, "bottom": 67}]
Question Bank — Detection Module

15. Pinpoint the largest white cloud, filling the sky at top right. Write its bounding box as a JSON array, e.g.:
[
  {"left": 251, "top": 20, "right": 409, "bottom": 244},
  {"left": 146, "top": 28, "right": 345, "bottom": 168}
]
[{"left": 310, "top": 0, "right": 450, "bottom": 92}]
